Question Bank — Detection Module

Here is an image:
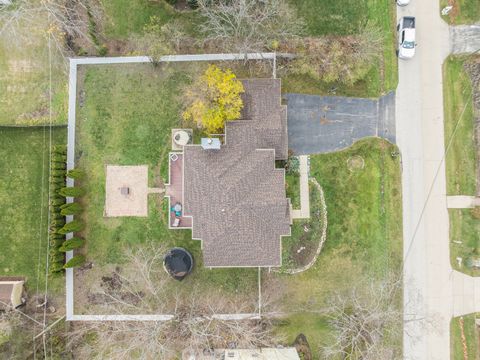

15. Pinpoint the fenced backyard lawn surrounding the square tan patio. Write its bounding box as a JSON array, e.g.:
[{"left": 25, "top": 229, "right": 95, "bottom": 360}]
[{"left": 76, "top": 64, "right": 257, "bottom": 314}]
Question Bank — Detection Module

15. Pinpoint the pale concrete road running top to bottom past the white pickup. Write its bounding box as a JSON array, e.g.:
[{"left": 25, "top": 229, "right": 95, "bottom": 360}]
[{"left": 396, "top": 0, "right": 480, "bottom": 360}]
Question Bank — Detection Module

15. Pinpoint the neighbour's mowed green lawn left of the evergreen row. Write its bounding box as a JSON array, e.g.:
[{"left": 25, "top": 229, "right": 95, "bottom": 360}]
[{"left": 0, "top": 127, "right": 66, "bottom": 295}]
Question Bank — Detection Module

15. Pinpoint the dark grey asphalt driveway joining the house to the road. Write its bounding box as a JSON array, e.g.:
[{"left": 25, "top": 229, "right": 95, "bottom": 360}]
[{"left": 285, "top": 92, "right": 396, "bottom": 155}]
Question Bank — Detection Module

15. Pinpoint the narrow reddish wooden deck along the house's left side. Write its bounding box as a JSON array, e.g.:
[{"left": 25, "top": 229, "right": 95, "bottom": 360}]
[{"left": 165, "top": 153, "right": 192, "bottom": 228}]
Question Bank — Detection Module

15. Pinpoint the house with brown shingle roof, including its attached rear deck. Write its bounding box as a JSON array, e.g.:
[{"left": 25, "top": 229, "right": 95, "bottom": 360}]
[{"left": 166, "top": 79, "right": 291, "bottom": 267}]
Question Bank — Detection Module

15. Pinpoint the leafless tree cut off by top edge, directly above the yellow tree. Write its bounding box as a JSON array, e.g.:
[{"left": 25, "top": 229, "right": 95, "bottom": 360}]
[{"left": 198, "top": 0, "right": 303, "bottom": 53}]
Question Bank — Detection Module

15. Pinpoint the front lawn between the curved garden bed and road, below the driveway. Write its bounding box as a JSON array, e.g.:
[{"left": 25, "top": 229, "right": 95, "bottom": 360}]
[{"left": 272, "top": 138, "right": 402, "bottom": 358}]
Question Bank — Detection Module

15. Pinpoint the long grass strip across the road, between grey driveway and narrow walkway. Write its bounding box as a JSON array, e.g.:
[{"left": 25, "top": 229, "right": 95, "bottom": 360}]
[{"left": 443, "top": 56, "right": 477, "bottom": 195}]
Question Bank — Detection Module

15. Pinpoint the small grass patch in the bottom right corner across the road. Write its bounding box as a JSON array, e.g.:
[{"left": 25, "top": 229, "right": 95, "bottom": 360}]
[{"left": 450, "top": 314, "right": 479, "bottom": 360}]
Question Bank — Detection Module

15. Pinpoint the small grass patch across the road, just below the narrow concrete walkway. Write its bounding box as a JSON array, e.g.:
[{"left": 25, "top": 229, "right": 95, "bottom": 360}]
[{"left": 448, "top": 209, "right": 480, "bottom": 276}]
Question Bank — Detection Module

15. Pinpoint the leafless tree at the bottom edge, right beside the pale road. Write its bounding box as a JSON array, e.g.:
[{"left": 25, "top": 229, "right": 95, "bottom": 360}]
[{"left": 323, "top": 280, "right": 403, "bottom": 360}]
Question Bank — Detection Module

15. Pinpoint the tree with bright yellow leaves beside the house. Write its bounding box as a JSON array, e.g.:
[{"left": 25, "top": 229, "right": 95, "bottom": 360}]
[{"left": 182, "top": 65, "right": 244, "bottom": 134}]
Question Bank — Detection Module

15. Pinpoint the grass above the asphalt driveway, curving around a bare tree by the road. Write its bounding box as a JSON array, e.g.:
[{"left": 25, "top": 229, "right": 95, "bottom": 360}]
[{"left": 283, "top": 0, "right": 398, "bottom": 97}]
